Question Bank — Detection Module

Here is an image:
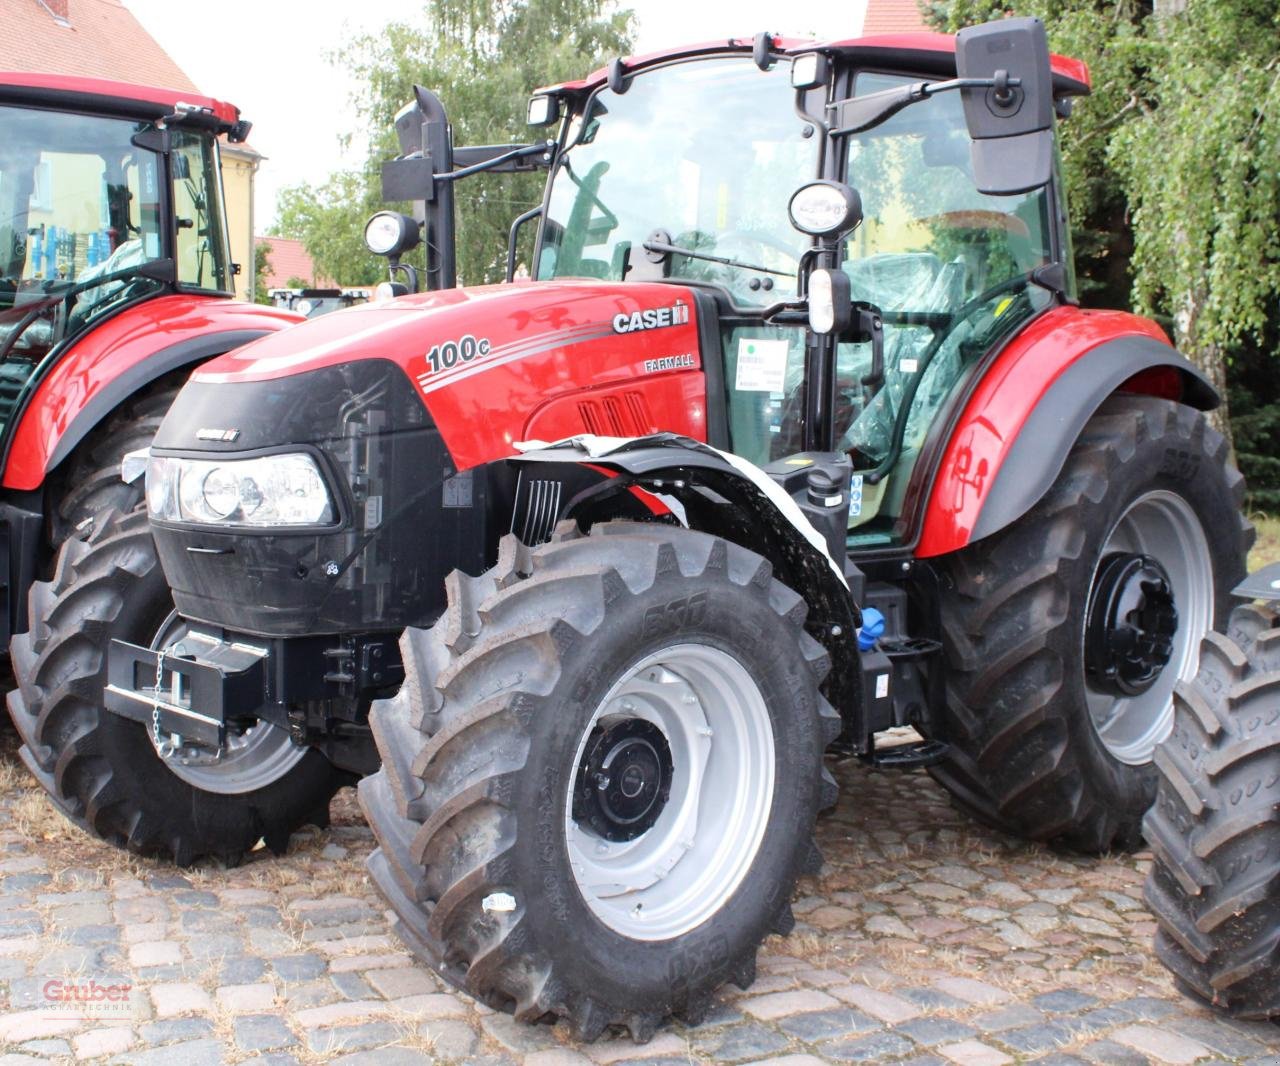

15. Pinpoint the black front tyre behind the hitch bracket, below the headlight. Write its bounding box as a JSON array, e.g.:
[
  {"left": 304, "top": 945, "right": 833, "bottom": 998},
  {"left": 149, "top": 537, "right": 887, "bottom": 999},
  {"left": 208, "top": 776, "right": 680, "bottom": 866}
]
[{"left": 8, "top": 507, "right": 355, "bottom": 865}]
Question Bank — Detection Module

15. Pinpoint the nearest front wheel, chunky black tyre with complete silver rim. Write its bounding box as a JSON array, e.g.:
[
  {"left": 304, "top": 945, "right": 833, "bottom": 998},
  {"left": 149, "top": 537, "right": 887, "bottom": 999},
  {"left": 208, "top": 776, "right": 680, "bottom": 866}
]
[{"left": 360, "top": 523, "right": 840, "bottom": 1040}]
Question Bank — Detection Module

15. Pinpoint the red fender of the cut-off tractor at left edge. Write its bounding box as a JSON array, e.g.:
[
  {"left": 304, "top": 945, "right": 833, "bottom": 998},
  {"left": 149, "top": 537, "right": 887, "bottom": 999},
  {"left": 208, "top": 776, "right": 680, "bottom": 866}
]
[{"left": 0, "top": 294, "right": 302, "bottom": 490}]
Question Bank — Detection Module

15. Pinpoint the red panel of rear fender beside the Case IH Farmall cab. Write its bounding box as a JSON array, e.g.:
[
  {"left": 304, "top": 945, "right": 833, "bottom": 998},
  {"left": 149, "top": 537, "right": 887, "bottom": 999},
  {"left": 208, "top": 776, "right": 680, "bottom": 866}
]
[{"left": 915, "top": 307, "right": 1172, "bottom": 558}]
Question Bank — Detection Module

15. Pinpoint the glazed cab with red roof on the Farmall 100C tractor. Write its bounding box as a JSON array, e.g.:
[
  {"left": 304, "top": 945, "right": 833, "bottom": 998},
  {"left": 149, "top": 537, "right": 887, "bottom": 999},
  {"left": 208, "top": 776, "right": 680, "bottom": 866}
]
[{"left": 531, "top": 23, "right": 1088, "bottom": 548}]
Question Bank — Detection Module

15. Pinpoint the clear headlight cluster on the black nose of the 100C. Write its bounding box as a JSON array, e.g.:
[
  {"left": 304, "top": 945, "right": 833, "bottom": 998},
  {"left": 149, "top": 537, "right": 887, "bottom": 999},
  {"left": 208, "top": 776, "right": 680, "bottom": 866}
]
[{"left": 147, "top": 454, "right": 334, "bottom": 526}]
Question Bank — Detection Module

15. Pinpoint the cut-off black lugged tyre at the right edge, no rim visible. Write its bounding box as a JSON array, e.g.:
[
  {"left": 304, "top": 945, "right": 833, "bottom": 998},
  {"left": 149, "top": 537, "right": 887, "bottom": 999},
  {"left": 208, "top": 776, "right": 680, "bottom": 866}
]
[{"left": 1144, "top": 607, "right": 1280, "bottom": 1020}]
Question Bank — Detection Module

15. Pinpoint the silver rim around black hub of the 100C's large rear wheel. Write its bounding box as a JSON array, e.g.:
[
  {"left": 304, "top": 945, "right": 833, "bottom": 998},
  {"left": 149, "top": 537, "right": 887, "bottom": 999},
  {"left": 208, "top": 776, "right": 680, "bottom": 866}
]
[{"left": 1085, "top": 489, "right": 1213, "bottom": 767}]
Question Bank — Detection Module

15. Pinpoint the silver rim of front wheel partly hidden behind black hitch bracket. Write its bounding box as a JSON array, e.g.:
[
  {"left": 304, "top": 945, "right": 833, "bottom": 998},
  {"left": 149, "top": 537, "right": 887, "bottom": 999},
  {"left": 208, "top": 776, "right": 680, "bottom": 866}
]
[{"left": 147, "top": 610, "right": 307, "bottom": 796}]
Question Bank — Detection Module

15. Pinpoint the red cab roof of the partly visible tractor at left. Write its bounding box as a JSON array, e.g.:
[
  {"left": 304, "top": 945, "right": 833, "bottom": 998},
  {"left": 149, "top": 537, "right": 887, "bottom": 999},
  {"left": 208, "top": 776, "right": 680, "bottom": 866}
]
[{"left": 0, "top": 70, "right": 239, "bottom": 133}]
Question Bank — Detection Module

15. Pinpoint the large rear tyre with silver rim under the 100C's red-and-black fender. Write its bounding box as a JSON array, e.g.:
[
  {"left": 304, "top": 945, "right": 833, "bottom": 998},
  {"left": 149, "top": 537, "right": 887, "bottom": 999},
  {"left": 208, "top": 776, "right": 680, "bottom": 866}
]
[{"left": 932, "top": 395, "right": 1253, "bottom": 852}]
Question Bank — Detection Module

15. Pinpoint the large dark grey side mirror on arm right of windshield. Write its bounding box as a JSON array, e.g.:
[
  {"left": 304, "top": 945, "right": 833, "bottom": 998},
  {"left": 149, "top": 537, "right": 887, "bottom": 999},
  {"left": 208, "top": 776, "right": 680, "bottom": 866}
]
[{"left": 956, "top": 18, "right": 1053, "bottom": 196}]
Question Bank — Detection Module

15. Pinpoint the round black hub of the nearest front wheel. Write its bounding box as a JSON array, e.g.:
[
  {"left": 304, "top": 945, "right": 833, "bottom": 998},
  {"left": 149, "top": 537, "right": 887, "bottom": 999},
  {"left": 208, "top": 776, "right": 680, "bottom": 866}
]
[{"left": 573, "top": 718, "right": 672, "bottom": 841}]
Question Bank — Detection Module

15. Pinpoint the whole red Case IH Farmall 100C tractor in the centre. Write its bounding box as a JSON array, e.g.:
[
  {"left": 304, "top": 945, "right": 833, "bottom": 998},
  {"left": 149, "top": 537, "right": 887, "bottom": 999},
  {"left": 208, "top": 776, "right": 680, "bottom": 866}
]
[{"left": 15, "top": 19, "right": 1277, "bottom": 1038}]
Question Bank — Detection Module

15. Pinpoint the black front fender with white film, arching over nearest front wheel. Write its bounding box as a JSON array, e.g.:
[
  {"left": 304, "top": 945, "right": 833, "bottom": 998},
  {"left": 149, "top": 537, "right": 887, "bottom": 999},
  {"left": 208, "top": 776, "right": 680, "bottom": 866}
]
[{"left": 508, "top": 434, "right": 861, "bottom": 720}]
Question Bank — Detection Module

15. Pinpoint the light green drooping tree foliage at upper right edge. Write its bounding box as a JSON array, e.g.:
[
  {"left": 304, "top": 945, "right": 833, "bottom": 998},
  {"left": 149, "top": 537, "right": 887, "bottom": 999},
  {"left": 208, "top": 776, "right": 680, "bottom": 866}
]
[{"left": 1108, "top": 0, "right": 1280, "bottom": 406}]
